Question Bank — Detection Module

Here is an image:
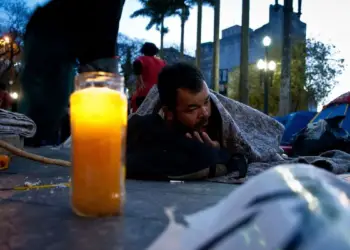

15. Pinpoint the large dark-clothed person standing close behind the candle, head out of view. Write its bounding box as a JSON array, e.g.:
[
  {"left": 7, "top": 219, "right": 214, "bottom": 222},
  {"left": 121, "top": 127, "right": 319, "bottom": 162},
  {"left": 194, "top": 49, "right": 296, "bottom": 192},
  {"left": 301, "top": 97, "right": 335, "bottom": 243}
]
[{"left": 19, "top": 0, "right": 125, "bottom": 146}]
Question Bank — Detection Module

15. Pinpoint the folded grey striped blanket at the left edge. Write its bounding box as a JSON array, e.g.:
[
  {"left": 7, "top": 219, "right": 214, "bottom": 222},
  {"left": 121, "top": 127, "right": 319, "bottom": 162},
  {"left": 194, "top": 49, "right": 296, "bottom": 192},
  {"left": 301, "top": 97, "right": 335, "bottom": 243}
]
[{"left": 0, "top": 109, "right": 36, "bottom": 138}]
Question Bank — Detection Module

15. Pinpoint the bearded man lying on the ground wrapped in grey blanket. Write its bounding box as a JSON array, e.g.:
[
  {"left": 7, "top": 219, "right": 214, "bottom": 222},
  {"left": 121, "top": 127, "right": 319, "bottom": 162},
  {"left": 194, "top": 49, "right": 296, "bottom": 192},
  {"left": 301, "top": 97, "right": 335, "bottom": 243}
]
[{"left": 127, "top": 63, "right": 284, "bottom": 179}]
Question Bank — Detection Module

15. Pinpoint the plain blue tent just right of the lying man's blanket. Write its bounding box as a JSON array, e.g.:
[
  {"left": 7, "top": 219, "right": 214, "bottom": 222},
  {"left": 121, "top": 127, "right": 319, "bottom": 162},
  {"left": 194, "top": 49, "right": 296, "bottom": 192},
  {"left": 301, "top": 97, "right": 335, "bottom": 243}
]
[{"left": 274, "top": 111, "right": 316, "bottom": 146}]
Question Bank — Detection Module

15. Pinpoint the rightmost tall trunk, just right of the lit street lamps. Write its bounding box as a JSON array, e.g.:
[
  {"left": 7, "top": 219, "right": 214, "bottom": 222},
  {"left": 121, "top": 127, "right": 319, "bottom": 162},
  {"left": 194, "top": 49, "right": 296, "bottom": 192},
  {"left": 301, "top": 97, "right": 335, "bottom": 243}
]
[{"left": 279, "top": 0, "right": 293, "bottom": 116}]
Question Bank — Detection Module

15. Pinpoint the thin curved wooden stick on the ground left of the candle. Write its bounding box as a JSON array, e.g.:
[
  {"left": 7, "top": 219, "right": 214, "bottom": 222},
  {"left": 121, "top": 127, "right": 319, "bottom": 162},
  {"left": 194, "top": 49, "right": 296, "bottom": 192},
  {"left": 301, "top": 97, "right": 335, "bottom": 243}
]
[{"left": 0, "top": 140, "right": 72, "bottom": 167}]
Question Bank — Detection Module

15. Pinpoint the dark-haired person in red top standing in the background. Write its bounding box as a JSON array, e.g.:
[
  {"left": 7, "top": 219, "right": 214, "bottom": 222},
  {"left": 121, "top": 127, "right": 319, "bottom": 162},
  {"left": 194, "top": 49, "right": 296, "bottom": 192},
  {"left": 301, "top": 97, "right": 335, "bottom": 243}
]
[{"left": 131, "top": 42, "right": 166, "bottom": 112}]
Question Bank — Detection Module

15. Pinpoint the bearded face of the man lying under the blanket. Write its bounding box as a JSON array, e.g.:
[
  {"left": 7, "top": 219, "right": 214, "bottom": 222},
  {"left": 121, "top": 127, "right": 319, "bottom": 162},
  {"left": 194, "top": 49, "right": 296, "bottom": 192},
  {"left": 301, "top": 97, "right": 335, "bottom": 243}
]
[{"left": 168, "top": 82, "right": 211, "bottom": 131}]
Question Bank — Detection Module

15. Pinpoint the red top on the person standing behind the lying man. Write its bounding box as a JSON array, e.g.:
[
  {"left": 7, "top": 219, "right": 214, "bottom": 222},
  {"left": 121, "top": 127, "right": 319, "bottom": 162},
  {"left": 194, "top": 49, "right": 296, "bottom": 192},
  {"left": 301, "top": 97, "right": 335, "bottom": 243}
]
[{"left": 136, "top": 56, "right": 165, "bottom": 97}]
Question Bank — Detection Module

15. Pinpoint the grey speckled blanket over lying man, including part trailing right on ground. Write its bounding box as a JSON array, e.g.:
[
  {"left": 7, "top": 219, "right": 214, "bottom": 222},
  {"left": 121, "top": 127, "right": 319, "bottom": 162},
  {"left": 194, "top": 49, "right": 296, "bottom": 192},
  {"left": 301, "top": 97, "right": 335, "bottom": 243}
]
[{"left": 136, "top": 86, "right": 350, "bottom": 183}]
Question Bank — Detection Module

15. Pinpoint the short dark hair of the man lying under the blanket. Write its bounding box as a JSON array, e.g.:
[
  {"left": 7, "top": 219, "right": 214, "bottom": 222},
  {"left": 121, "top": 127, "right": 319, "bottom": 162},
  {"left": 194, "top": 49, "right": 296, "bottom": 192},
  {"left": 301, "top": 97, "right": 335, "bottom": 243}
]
[{"left": 157, "top": 62, "right": 205, "bottom": 110}]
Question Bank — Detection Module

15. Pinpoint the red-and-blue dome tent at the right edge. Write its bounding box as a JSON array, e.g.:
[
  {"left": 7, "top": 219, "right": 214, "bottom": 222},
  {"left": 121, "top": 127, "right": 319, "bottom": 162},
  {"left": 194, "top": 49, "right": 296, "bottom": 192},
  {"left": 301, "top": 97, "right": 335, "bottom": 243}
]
[{"left": 310, "top": 92, "right": 350, "bottom": 133}]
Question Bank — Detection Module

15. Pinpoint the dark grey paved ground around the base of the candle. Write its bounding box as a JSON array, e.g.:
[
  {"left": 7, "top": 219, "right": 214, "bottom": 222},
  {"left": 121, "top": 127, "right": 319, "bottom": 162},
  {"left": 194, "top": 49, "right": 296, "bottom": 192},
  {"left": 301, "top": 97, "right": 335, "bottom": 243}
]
[{"left": 0, "top": 148, "right": 235, "bottom": 250}]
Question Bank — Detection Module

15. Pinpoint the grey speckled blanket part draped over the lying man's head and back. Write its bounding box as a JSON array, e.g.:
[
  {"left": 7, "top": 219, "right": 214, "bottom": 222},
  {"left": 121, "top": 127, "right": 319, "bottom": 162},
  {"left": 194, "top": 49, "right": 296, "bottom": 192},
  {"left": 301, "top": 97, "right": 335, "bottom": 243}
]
[{"left": 130, "top": 86, "right": 284, "bottom": 162}]
